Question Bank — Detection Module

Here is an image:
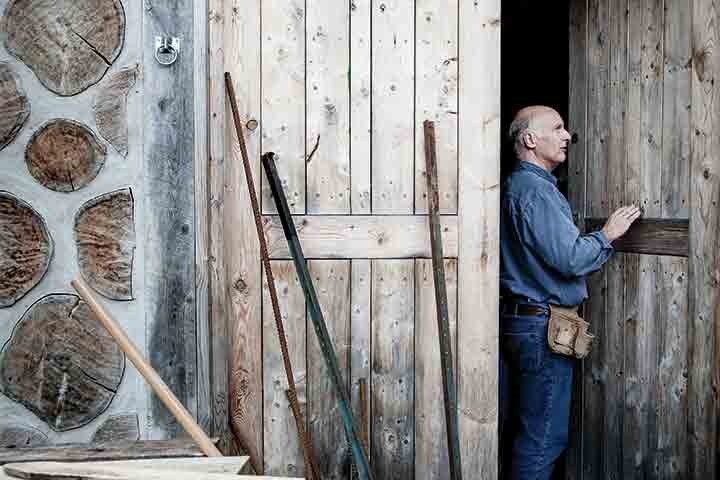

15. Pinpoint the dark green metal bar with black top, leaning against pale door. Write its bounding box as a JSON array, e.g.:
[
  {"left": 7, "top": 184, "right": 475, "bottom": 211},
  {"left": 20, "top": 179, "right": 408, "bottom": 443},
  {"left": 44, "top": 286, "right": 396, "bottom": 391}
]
[{"left": 262, "top": 152, "right": 373, "bottom": 480}]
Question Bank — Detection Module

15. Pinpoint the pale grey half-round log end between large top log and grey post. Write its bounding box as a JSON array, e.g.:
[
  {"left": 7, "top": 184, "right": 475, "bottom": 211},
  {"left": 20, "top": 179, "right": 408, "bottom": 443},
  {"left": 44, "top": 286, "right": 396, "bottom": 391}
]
[{"left": 93, "top": 66, "right": 139, "bottom": 157}]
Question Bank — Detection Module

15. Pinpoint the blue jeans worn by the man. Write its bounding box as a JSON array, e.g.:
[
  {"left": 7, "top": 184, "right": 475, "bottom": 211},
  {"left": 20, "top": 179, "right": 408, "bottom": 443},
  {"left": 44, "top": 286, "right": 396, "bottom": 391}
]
[{"left": 500, "top": 314, "right": 575, "bottom": 480}]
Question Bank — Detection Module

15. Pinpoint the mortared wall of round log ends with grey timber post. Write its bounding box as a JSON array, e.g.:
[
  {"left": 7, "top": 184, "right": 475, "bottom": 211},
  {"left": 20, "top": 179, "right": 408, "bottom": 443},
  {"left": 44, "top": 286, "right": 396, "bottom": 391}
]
[{"left": 0, "top": 0, "right": 208, "bottom": 443}]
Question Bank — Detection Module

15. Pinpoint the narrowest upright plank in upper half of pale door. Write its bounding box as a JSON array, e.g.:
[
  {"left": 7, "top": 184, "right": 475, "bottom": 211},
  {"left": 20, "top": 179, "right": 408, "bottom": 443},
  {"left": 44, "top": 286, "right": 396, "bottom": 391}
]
[{"left": 350, "top": 0, "right": 372, "bottom": 214}]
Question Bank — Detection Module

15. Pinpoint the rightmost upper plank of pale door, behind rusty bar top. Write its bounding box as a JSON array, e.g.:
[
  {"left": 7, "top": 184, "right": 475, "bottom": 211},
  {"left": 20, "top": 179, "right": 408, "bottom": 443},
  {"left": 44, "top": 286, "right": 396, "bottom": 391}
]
[{"left": 415, "top": 0, "right": 458, "bottom": 214}]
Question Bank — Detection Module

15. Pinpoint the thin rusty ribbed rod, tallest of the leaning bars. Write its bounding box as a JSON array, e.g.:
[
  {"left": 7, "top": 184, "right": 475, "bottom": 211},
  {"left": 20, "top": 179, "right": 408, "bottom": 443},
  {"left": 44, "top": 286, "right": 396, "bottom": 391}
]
[{"left": 225, "top": 72, "right": 320, "bottom": 480}]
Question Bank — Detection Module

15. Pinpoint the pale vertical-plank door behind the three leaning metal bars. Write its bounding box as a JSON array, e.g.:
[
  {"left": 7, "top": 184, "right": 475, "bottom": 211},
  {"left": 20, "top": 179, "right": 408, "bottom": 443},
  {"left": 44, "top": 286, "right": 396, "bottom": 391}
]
[{"left": 211, "top": 0, "right": 500, "bottom": 480}]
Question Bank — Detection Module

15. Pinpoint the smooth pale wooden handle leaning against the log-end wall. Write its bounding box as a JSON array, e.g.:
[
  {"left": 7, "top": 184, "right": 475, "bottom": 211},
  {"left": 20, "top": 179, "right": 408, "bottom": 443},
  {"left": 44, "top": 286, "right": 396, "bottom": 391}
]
[{"left": 70, "top": 278, "right": 222, "bottom": 457}]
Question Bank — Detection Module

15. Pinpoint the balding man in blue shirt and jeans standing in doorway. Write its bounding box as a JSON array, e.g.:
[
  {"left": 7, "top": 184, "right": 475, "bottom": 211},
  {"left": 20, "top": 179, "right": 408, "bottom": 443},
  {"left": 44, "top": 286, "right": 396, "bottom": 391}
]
[{"left": 500, "top": 106, "right": 640, "bottom": 480}]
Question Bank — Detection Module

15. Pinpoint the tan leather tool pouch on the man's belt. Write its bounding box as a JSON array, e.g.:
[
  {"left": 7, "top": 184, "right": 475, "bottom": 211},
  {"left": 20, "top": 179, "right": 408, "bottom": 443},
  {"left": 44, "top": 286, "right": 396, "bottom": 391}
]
[{"left": 548, "top": 305, "right": 595, "bottom": 358}]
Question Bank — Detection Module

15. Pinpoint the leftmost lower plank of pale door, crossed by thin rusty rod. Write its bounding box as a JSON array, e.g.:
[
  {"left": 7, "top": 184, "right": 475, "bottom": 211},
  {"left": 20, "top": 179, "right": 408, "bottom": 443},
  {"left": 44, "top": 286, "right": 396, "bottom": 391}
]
[{"left": 262, "top": 260, "right": 307, "bottom": 476}]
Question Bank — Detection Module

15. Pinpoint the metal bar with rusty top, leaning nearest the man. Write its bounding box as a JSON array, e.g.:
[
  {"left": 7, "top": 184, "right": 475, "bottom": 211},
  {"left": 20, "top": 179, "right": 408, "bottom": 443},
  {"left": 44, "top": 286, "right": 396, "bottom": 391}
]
[{"left": 423, "top": 120, "right": 462, "bottom": 480}]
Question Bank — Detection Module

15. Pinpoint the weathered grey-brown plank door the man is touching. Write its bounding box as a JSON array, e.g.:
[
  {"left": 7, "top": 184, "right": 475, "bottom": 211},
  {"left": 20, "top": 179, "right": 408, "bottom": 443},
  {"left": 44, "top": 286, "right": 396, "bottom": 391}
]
[{"left": 568, "top": 0, "right": 720, "bottom": 479}]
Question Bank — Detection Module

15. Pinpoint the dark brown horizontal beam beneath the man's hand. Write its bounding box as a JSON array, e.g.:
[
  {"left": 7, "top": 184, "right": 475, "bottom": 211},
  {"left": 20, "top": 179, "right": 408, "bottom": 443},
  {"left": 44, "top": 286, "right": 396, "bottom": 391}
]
[{"left": 585, "top": 218, "right": 690, "bottom": 257}]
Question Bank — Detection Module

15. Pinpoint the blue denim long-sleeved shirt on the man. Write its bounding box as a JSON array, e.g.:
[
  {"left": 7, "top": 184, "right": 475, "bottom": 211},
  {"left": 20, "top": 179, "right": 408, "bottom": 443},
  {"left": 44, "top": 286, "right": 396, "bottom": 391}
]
[{"left": 500, "top": 161, "right": 613, "bottom": 306}]
